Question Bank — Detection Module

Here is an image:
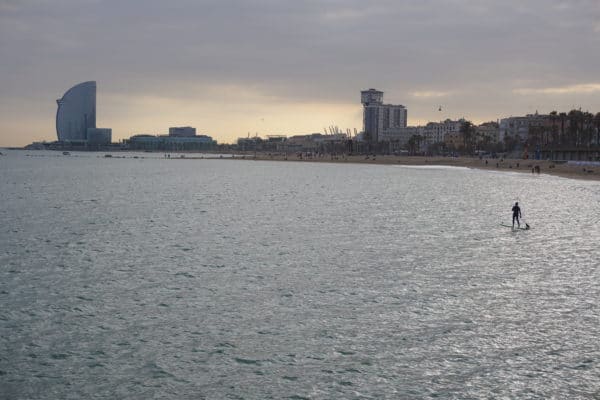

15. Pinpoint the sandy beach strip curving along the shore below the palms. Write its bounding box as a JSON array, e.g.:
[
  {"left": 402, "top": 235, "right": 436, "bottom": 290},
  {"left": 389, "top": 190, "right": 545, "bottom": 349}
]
[{"left": 229, "top": 153, "right": 600, "bottom": 180}]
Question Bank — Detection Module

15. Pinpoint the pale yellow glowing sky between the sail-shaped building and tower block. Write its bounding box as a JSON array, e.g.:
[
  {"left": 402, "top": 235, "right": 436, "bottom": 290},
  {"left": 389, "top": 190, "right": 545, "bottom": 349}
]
[{"left": 98, "top": 88, "right": 362, "bottom": 143}]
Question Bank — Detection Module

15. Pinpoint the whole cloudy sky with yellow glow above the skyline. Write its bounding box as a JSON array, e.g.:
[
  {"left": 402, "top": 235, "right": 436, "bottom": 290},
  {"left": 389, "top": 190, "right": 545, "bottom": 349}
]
[{"left": 0, "top": 0, "right": 600, "bottom": 146}]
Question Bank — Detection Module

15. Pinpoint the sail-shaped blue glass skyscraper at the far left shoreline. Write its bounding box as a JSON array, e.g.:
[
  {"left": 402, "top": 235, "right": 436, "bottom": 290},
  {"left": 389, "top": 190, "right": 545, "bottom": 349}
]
[{"left": 56, "top": 81, "right": 96, "bottom": 142}]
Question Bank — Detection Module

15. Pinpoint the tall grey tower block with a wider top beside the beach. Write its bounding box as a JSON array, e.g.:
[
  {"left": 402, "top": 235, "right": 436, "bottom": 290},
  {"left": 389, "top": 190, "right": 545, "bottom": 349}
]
[{"left": 360, "top": 89, "right": 408, "bottom": 143}]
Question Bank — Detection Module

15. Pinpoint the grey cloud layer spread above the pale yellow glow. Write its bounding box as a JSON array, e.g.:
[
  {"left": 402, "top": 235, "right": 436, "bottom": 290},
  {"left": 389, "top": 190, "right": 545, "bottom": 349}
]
[{"left": 0, "top": 0, "right": 600, "bottom": 143}]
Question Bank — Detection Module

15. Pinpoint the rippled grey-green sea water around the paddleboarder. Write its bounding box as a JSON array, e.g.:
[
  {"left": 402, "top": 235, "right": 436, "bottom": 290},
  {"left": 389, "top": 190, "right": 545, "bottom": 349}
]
[{"left": 0, "top": 150, "right": 600, "bottom": 399}]
